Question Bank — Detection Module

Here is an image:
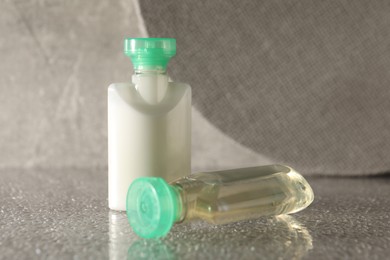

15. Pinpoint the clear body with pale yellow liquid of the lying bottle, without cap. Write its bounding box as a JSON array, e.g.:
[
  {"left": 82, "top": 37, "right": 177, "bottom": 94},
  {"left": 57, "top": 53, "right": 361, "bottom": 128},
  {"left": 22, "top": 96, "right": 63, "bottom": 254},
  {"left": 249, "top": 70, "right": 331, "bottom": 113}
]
[{"left": 171, "top": 165, "right": 314, "bottom": 224}]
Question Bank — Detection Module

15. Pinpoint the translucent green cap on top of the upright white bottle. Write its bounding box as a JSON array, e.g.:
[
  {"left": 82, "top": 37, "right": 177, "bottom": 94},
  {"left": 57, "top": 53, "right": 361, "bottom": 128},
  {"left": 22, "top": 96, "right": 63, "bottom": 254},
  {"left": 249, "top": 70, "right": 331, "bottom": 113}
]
[{"left": 125, "top": 38, "right": 176, "bottom": 71}]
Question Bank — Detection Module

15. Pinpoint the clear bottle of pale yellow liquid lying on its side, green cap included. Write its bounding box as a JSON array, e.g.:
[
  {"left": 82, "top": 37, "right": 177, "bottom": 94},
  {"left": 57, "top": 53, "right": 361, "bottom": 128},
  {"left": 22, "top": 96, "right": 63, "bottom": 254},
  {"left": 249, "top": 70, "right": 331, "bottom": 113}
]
[{"left": 127, "top": 165, "right": 314, "bottom": 238}]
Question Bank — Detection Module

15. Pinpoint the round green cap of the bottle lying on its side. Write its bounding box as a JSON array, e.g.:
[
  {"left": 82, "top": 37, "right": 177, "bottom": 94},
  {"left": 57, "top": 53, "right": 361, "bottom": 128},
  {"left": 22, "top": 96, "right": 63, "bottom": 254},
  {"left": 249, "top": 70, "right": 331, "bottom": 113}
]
[{"left": 126, "top": 177, "right": 181, "bottom": 238}]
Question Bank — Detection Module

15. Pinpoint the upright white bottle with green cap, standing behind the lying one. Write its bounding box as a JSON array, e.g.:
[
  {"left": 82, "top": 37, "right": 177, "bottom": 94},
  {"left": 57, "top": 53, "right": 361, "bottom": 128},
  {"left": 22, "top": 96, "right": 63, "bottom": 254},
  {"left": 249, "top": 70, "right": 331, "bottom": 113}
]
[{"left": 108, "top": 38, "right": 191, "bottom": 210}]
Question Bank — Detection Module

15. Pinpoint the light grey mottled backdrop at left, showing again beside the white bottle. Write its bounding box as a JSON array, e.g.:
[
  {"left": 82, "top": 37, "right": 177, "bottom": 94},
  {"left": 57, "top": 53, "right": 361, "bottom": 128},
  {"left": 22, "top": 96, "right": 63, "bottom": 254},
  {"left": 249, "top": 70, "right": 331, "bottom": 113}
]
[{"left": 0, "top": 0, "right": 270, "bottom": 174}]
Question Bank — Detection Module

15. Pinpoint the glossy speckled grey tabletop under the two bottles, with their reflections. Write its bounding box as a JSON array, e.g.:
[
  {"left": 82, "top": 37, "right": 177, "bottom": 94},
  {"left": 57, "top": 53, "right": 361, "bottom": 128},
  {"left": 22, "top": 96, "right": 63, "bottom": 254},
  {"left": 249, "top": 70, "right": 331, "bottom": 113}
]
[{"left": 0, "top": 170, "right": 390, "bottom": 259}]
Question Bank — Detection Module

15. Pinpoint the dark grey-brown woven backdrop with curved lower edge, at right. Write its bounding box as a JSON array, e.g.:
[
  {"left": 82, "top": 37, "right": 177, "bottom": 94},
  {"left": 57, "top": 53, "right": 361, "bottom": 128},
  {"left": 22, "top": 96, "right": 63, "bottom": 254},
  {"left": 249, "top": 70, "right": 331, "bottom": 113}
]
[{"left": 140, "top": 0, "right": 390, "bottom": 175}]
